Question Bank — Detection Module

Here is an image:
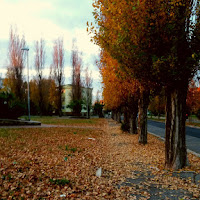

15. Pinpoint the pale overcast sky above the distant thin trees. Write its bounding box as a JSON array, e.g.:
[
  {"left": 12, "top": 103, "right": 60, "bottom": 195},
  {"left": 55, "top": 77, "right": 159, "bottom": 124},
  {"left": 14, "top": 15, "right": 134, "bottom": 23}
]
[{"left": 0, "top": 0, "right": 101, "bottom": 97}]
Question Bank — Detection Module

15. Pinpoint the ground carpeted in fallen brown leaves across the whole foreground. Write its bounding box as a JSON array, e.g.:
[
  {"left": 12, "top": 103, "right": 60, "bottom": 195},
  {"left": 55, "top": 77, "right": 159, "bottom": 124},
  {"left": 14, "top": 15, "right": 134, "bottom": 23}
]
[{"left": 0, "top": 119, "right": 200, "bottom": 199}]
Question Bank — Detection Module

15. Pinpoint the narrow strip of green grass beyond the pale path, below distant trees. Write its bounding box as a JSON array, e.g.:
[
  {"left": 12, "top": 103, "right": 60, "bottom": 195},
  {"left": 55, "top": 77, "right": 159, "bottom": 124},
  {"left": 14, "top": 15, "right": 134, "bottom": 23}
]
[{"left": 25, "top": 116, "right": 98, "bottom": 125}]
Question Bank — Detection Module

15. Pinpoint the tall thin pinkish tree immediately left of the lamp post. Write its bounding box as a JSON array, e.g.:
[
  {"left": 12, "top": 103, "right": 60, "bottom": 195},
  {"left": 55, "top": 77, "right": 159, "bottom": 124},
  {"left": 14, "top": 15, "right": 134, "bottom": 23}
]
[{"left": 6, "top": 27, "right": 26, "bottom": 101}]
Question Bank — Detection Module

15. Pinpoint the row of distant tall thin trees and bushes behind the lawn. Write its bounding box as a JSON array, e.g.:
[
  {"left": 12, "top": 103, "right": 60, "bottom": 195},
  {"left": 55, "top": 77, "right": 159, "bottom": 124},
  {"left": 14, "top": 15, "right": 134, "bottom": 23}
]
[{"left": 0, "top": 27, "right": 92, "bottom": 118}]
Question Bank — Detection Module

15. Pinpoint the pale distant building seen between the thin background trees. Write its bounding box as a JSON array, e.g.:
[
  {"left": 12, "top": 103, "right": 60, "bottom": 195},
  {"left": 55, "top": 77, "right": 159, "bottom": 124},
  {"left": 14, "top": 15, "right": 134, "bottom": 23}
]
[{"left": 62, "top": 84, "right": 93, "bottom": 115}]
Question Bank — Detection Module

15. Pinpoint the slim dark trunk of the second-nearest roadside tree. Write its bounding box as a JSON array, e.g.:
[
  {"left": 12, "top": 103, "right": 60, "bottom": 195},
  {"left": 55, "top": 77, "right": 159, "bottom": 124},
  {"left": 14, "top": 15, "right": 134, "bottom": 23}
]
[{"left": 138, "top": 89, "right": 149, "bottom": 144}]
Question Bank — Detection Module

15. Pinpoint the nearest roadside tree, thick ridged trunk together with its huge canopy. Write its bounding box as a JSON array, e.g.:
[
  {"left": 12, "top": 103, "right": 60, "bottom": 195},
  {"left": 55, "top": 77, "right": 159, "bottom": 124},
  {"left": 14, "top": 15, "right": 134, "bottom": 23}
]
[{"left": 92, "top": 0, "right": 200, "bottom": 168}]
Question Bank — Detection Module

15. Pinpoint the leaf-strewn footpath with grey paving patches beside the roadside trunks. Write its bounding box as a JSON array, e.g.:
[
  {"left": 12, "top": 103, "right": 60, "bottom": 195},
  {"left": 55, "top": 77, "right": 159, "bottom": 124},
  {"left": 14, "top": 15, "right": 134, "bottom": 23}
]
[{"left": 105, "top": 119, "right": 200, "bottom": 200}]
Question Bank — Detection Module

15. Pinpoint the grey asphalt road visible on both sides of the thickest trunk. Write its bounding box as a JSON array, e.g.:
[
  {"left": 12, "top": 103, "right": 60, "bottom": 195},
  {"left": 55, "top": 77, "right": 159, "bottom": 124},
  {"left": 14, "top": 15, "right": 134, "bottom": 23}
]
[{"left": 147, "top": 120, "right": 200, "bottom": 156}]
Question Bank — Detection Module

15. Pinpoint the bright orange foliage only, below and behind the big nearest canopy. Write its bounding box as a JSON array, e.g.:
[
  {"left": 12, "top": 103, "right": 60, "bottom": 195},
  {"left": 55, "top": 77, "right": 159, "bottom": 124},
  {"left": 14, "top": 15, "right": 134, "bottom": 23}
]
[{"left": 99, "top": 51, "right": 138, "bottom": 109}]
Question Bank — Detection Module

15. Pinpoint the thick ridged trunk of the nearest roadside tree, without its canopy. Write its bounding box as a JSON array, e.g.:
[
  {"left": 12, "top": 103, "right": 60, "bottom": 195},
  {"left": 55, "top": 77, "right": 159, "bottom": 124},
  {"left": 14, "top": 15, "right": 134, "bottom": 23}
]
[{"left": 165, "top": 85, "right": 187, "bottom": 169}]
